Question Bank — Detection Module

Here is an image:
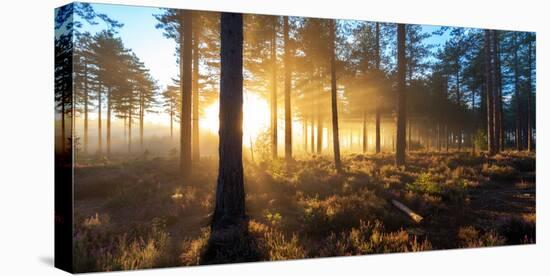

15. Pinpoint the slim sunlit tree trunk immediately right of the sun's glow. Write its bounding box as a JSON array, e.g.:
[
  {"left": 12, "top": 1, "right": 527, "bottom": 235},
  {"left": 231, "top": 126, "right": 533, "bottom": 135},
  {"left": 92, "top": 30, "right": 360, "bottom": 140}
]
[{"left": 271, "top": 16, "right": 280, "bottom": 159}]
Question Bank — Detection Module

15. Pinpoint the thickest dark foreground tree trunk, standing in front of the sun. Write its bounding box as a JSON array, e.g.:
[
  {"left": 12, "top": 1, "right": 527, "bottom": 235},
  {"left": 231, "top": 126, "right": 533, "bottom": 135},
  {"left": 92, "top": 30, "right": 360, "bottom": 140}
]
[{"left": 212, "top": 12, "right": 245, "bottom": 230}]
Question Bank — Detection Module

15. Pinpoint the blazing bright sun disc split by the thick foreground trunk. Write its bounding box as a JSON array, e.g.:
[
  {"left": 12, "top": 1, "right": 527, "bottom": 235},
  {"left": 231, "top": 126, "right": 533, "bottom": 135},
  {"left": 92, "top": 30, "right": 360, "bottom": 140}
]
[{"left": 203, "top": 92, "right": 270, "bottom": 143}]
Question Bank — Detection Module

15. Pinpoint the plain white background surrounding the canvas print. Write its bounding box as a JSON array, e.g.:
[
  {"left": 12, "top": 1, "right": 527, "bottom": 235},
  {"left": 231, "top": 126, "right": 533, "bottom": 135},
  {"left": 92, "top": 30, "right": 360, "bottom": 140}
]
[{"left": 0, "top": 0, "right": 550, "bottom": 276}]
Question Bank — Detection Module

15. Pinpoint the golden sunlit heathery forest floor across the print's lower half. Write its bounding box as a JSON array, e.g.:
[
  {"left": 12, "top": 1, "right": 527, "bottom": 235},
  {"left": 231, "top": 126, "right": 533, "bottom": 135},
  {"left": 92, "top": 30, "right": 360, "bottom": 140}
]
[{"left": 74, "top": 152, "right": 536, "bottom": 272}]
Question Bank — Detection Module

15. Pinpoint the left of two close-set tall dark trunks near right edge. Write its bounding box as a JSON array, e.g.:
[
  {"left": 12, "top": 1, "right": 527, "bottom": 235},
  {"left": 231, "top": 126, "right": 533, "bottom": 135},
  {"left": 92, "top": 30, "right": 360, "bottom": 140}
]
[{"left": 484, "top": 30, "right": 496, "bottom": 155}]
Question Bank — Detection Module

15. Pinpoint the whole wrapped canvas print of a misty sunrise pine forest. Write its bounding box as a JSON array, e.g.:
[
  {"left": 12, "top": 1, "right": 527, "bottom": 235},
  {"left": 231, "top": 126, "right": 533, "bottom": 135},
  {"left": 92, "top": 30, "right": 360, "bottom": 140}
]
[{"left": 55, "top": 3, "right": 537, "bottom": 272}]
